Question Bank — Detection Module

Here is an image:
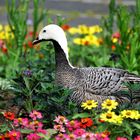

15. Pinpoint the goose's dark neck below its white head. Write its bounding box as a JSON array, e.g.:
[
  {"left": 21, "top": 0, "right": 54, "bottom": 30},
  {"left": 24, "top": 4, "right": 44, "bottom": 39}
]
[{"left": 53, "top": 41, "right": 72, "bottom": 70}]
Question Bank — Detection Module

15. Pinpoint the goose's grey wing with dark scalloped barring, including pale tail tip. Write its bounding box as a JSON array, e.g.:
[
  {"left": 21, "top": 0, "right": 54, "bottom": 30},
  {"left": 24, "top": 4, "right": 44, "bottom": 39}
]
[{"left": 76, "top": 68, "right": 140, "bottom": 96}]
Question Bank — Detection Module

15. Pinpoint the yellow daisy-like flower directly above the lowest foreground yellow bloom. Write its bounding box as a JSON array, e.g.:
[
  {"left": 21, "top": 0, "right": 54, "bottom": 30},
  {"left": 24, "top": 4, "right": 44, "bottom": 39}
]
[{"left": 102, "top": 99, "right": 118, "bottom": 110}]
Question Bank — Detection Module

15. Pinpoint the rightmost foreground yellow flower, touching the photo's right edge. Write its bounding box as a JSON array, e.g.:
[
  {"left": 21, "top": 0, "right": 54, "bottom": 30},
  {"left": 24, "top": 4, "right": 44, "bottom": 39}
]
[{"left": 121, "top": 110, "right": 140, "bottom": 119}]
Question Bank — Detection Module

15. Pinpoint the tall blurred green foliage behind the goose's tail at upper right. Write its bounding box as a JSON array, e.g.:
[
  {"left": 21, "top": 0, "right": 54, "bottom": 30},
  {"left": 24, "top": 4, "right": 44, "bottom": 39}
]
[{"left": 103, "top": 0, "right": 140, "bottom": 73}]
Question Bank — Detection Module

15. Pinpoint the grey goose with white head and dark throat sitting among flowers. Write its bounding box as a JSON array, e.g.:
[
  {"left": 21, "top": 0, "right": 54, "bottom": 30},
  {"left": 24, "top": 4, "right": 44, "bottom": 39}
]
[{"left": 33, "top": 24, "right": 140, "bottom": 105}]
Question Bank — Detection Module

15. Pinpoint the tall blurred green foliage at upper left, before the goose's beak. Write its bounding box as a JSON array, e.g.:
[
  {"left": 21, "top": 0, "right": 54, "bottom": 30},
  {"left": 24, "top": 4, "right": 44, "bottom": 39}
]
[{"left": 0, "top": 0, "right": 46, "bottom": 78}]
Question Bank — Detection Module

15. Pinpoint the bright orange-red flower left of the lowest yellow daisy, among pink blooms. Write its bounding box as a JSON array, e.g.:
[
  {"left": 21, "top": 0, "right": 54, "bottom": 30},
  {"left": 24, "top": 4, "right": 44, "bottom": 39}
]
[{"left": 80, "top": 118, "right": 93, "bottom": 128}]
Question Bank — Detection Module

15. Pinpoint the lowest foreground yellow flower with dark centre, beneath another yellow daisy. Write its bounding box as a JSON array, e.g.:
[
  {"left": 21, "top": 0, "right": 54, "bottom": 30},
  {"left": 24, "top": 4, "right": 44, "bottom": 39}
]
[{"left": 100, "top": 111, "right": 121, "bottom": 123}]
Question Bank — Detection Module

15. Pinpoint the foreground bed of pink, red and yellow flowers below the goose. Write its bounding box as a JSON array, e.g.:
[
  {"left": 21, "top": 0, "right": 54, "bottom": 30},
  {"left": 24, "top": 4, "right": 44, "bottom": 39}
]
[{"left": 0, "top": 99, "right": 140, "bottom": 140}]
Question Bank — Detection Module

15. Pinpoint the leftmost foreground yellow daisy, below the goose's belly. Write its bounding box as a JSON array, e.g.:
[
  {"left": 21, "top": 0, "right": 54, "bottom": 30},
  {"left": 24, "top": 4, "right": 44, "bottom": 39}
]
[{"left": 81, "top": 100, "right": 97, "bottom": 110}]
